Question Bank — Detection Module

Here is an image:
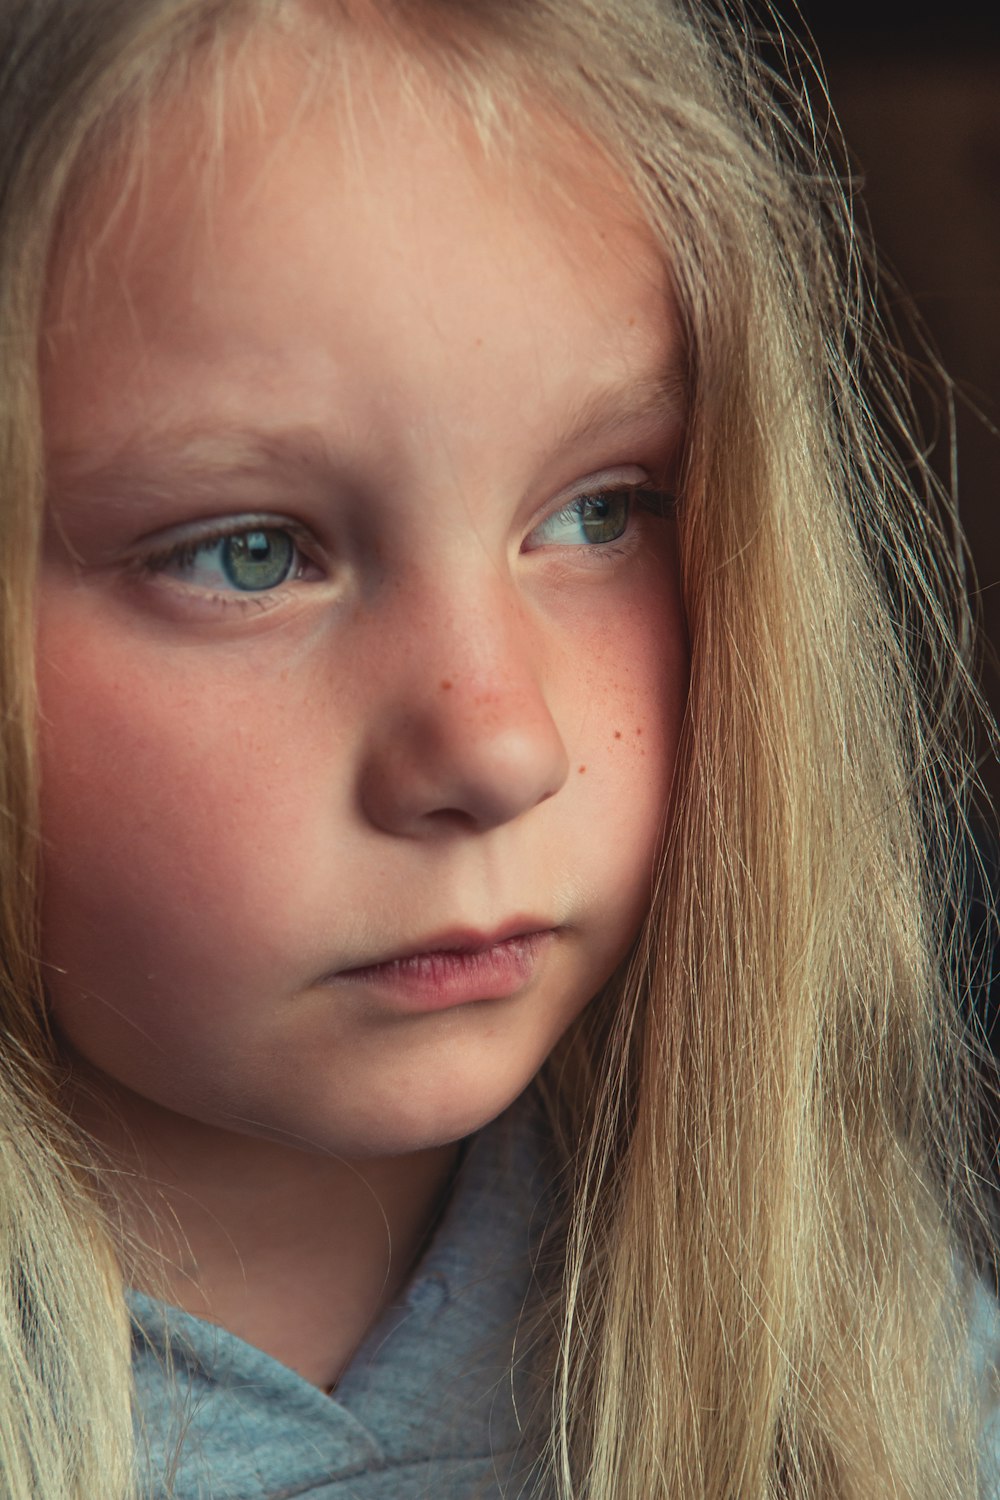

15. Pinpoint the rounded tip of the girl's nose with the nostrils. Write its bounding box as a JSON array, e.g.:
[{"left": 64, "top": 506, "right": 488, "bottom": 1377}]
[{"left": 361, "top": 680, "right": 570, "bottom": 837}]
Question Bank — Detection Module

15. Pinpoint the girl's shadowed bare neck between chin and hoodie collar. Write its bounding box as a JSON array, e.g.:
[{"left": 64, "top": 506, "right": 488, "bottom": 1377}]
[{"left": 70, "top": 1068, "right": 459, "bottom": 1391}]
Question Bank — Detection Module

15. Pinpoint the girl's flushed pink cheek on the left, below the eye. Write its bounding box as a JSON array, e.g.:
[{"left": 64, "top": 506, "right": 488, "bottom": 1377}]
[{"left": 39, "top": 609, "right": 334, "bottom": 1020}]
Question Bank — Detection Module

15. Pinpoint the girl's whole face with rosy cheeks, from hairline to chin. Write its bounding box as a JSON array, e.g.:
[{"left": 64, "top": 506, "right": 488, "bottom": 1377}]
[{"left": 37, "top": 41, "right": 687, "bottom": 1155}]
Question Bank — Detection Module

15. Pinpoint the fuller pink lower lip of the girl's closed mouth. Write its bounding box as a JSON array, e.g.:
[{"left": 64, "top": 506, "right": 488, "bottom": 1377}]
[{"left": 331, "top": 929, "right": 555, "bottom": 1011}]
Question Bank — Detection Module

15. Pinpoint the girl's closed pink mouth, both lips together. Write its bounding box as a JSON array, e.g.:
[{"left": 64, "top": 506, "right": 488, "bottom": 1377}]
[{"left": 322, "top": 918, "right": 556, "bottom": 1013}]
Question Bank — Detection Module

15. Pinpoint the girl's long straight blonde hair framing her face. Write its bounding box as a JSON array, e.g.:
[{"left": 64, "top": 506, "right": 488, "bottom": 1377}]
[{"left": 0, "top": 0, "right": 997, "bottom": 1500}]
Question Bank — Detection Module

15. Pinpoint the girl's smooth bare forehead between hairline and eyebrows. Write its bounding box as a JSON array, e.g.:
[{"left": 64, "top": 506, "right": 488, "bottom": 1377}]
[{"left": 43, "top": 29, "right": 676, "bottom": 474}]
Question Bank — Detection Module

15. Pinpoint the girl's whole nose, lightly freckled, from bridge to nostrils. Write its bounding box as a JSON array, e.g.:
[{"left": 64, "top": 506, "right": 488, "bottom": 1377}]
[{"left": 360, "top": 587, "right": 568, "bottom": 837}]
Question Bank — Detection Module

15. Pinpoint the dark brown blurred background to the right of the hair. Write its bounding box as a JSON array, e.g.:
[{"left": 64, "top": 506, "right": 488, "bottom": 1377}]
[{"left": 775, "top": 0, "right": 1000, "bottom": 1074}]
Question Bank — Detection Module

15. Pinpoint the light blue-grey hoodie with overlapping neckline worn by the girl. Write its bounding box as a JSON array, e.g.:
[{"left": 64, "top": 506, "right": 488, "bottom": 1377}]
[{"left": 127, "top": 1091, "right": 1000, "bottom": 1500}]
